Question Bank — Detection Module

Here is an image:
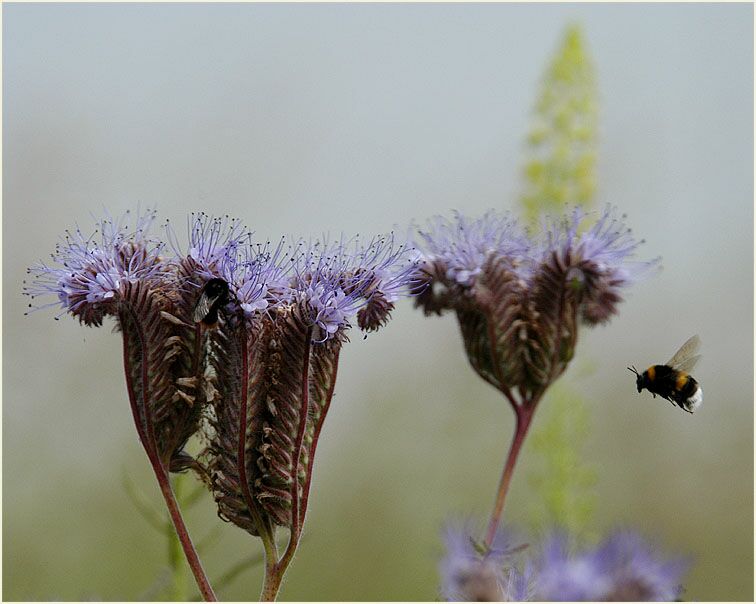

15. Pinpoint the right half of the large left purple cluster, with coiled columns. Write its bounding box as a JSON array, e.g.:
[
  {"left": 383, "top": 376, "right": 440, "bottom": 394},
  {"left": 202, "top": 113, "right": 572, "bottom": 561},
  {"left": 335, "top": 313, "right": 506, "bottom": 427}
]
[{"left": 211, "top": 237, "right": 417, "bottom": 534}]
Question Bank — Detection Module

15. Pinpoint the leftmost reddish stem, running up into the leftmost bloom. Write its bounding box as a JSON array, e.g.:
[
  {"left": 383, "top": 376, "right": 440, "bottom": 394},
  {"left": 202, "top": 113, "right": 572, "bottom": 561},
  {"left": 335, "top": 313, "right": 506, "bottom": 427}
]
[{"left": 120, "top": 307, "right": 217, "bottom": 602}]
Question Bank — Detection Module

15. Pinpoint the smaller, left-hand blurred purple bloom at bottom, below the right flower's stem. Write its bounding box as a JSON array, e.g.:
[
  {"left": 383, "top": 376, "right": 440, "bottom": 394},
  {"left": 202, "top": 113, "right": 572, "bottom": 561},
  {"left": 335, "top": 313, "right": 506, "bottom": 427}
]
[{"left": 440, "top": 523, "right": 529, "bottom": 602}]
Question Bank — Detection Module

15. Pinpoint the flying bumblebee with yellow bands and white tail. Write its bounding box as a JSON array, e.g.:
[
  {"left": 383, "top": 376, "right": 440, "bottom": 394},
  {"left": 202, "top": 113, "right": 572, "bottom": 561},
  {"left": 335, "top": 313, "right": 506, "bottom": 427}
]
[{"left": 628, "top": 336, "right": 703, "bottom": 413}]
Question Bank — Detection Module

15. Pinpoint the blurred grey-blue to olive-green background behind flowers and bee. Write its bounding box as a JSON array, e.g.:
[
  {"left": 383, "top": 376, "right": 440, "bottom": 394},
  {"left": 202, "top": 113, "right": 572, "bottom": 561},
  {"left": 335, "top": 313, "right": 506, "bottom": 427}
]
[{"left": 3, "top": 4, "right": 754, "bottom": 600}]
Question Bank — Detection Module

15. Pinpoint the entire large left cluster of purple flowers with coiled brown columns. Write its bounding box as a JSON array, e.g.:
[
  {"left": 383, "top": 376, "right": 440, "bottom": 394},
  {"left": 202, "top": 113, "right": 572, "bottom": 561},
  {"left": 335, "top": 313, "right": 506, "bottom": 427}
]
[{"left": 25, "top": 212, "right": 417, "bottom": 535}]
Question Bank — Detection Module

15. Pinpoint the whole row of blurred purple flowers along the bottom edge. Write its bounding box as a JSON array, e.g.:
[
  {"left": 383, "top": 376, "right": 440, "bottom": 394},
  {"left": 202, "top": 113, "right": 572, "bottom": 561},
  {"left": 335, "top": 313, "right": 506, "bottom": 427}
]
[{"left": 440, "top": 522, "right": 689, "bottom": 602}]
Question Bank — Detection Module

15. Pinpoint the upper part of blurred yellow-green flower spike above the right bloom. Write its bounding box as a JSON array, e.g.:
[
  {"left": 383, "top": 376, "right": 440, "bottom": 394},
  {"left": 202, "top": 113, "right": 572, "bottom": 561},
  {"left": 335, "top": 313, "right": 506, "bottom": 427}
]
[{"left": 520, "top": 25, "right": 598, "bottom": 223}]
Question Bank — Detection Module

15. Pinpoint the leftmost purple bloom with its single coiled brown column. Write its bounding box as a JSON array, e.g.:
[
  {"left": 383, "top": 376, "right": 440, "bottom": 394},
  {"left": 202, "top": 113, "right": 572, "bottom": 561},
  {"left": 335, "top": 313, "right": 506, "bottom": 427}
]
[{"left": 26, "top": 212, "right": 211, "bottom": 469}]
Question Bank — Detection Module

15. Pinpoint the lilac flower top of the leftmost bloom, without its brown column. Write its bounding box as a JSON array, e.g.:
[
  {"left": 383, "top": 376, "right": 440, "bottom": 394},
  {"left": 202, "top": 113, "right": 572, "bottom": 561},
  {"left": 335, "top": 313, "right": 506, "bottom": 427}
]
[{"left": 24, "top": 211, "right": 168, "bottom": 325}]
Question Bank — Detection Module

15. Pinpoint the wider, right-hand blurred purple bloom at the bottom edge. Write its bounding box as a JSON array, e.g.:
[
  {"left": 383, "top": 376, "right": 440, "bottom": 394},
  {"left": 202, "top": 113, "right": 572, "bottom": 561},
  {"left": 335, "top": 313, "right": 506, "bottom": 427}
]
[{"left": 535, "top": 531, "right": 688, "bottom": 602}]
